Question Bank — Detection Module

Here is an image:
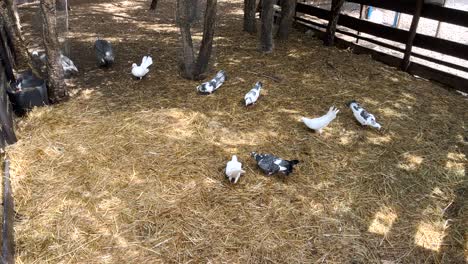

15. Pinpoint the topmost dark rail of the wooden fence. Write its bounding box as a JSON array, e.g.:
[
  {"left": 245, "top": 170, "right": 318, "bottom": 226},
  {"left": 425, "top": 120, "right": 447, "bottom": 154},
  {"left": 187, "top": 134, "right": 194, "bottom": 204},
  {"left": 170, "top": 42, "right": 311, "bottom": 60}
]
[{"left": 347, "top": 0, "right": 468, "bottom": 27}]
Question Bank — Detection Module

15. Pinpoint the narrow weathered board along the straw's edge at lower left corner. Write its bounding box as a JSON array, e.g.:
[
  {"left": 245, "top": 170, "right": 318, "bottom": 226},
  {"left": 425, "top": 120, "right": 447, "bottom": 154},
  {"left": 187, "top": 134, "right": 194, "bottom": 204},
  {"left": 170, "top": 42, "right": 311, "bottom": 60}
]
[{"left": 2, "top": 158, "right": 15, "bottom": 264}]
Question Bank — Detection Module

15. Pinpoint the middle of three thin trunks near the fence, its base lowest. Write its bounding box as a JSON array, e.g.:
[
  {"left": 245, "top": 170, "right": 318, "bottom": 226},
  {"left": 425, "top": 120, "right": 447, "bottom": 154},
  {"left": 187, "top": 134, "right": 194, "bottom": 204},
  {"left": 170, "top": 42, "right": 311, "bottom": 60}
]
[{"left": 260, "top": 0, "right": 275, "bottom": 53}]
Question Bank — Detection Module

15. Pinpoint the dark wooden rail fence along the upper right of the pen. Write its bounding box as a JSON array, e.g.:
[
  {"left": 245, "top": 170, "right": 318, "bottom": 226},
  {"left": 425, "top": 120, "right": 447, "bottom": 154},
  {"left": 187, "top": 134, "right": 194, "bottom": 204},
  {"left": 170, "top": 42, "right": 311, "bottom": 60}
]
[{"left": 295, "top": 0, "right": 468, "bottom": 92}]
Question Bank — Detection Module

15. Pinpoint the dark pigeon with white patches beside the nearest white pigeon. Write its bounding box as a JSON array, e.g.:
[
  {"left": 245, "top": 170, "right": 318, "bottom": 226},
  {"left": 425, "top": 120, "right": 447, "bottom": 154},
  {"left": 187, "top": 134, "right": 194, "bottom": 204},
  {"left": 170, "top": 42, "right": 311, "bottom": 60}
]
[{"left": 250, "top": 152, "right": 299, "bottom": 176}]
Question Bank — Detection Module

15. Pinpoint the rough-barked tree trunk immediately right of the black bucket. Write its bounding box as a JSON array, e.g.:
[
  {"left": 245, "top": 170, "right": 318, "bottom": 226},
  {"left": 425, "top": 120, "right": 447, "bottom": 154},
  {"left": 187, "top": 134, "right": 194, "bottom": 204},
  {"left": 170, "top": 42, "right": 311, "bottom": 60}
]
[{"left": 40, "top": 0, "right": 68, "bottom": 103}]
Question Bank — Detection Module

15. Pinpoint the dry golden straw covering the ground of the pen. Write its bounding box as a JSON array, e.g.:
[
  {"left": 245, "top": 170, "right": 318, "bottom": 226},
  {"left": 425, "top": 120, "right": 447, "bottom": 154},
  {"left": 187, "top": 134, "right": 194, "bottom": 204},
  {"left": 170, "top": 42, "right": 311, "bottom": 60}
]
[{"left": 7, "top": 0, "right": 468, "bottom": 264}]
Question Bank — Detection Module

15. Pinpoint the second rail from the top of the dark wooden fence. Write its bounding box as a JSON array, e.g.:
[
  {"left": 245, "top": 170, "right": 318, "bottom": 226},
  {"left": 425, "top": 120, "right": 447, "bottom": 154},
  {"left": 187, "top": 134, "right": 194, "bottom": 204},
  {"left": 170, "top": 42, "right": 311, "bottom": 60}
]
[{"left": 297, "top": 3, "right": 468, "bottom": 60}]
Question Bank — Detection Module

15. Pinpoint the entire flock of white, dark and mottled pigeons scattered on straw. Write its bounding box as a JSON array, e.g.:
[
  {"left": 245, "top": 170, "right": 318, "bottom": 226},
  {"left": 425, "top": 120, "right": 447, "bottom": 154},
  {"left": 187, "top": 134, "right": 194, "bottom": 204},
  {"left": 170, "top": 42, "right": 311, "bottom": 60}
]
[{"left": 33, "top": 39, "right": 381, "bottom": 183}]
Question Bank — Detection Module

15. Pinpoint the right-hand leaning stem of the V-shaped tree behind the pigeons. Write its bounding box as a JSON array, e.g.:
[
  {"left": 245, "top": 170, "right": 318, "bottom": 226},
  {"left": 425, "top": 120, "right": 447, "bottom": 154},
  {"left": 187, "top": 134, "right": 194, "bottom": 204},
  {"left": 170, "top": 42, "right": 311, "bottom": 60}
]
[{"left": 193, "top": 0, "right": 218, "bottom": 79}]
